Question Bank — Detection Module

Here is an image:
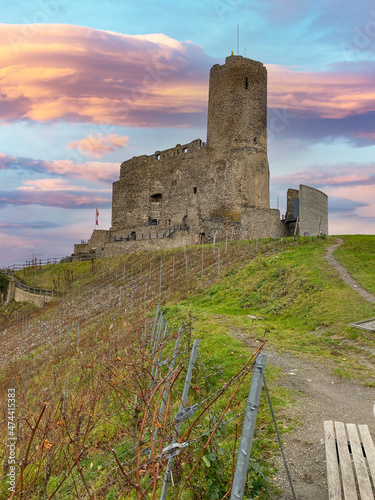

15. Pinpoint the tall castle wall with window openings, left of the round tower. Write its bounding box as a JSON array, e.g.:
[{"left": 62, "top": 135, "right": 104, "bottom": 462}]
[{"left": 112, "top": 139, "right": 210, "bottom": 230}]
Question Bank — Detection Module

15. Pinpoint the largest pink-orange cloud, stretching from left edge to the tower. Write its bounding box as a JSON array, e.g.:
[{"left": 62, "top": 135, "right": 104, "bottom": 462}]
[{"left": 0, "top": 24, "right": 212, "bottom": 127}]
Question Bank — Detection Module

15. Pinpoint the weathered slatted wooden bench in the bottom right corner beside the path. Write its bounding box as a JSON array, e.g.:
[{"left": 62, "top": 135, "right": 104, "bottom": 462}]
[{"left": 324, "top": 420, "right": 375, "bottom": 500}]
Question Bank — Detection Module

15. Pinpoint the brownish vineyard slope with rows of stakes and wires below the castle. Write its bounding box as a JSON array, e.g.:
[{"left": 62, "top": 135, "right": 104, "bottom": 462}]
[{"left": 0, "top": 239, "right": 290, "bottom": 500}]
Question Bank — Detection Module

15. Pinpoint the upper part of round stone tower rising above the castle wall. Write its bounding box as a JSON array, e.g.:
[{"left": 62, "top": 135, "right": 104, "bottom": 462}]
[{"left": 207, "top": 56, "right": 267, "bottom": 150}]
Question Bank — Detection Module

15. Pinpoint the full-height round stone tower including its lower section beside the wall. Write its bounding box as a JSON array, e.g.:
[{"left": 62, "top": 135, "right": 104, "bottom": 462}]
[{"left": 207, "top": 56, "right": 269, "bottom": 208}]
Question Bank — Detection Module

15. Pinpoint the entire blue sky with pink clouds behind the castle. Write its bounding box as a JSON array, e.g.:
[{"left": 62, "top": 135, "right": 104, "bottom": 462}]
[{"left": 0, "top": 0, "right": 375, "bottom": 267}]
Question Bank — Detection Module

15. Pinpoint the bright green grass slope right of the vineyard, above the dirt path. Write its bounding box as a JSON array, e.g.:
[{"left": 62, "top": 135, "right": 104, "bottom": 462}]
[{"left": 170, "top": 237, "right": 375, "bottom": 385}]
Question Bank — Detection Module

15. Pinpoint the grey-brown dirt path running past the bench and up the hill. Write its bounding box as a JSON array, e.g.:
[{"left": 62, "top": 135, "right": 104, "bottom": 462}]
[{"left": 219, "top": 239, "right": 375, "bottom": 500}]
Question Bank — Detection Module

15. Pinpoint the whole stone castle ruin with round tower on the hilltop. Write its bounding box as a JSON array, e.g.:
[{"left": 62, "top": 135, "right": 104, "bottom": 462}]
[{"left": 73, "top": 55, "right": 328, "bottom": 258}]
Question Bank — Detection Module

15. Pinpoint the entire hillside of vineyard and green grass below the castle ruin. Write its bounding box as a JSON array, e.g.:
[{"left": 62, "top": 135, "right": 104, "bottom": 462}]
[{"left": 0, "top": 236, "right": 375, "bottom": 499}]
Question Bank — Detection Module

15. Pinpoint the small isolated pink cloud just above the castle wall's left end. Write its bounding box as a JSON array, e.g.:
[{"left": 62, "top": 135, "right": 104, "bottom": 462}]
[{"left": 67, "top": 134, "right": 129, "bottom": 158}]
